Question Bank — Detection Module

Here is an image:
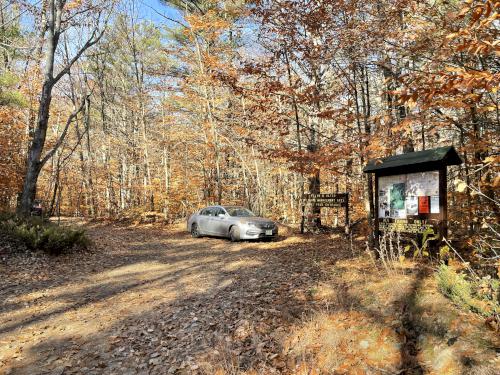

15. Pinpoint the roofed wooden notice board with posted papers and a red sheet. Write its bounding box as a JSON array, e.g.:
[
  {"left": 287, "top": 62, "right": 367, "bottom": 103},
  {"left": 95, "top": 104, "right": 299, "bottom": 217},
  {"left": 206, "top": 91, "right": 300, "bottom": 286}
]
[{"left": 364, "top": 146, "right": 462, "bottom": 248}]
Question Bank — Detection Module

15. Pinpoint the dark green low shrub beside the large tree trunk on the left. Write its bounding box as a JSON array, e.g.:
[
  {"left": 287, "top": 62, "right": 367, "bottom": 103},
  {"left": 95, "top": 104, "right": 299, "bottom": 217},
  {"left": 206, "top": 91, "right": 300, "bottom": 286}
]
[{"left": 0, "top": 214, "right": 90, "bottom": 255}]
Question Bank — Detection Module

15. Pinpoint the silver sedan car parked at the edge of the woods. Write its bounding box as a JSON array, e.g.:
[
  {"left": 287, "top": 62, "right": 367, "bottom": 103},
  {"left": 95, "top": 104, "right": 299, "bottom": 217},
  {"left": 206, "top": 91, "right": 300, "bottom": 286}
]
[{"left": 187, "top": 206, "right": 278, "bottom": 241}]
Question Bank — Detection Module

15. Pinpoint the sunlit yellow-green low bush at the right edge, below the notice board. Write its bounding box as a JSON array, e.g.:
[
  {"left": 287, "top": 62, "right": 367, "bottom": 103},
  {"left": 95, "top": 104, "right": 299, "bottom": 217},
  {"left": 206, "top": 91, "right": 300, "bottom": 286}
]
[{"left": 436, "top": 264, "right": 500, "bottom": 316}]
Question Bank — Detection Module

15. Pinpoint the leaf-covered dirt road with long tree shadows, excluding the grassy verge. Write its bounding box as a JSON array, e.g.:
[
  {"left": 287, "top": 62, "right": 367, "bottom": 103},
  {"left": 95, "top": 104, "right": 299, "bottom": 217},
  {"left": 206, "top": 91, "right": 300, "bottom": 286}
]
[{"left": 0, "top": 226, "right": 349, "bottom": 374}]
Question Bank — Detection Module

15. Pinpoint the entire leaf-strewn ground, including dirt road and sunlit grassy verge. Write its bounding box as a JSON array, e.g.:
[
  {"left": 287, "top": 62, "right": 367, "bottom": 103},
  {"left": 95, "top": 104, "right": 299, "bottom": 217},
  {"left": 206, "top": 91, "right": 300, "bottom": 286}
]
[{"left": 0, "top": 224, "right": 500, "bottom": 375}]
